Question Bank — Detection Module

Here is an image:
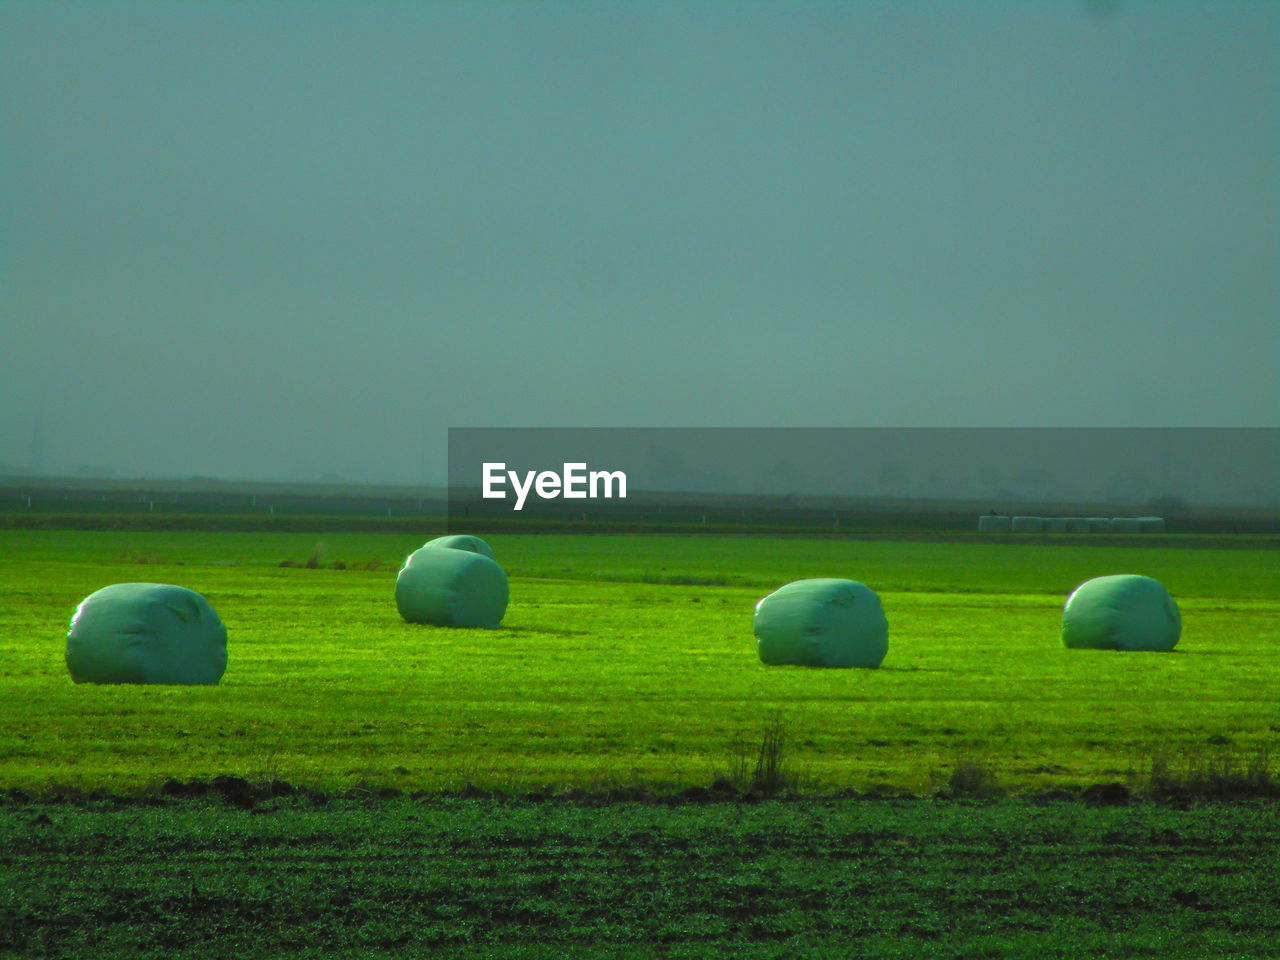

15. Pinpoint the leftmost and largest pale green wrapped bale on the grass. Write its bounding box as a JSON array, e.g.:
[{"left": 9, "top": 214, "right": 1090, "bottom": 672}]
[{"left": 67, "top": 584, "right": 227, "bottom": 685}]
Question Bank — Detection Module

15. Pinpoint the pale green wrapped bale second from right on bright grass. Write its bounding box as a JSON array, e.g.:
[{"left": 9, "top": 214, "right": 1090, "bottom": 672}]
[{"left": 754, "top": 580, "right": 888, "bottom": 668}]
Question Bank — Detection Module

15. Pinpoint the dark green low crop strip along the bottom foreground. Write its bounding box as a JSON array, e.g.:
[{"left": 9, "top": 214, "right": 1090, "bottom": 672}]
[{"left": 0, "top": 799, "right": 1280, "bottom": 957}]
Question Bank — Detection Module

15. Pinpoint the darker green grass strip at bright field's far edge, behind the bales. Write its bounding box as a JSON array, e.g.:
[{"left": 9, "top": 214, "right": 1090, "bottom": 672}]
[{"left": 0, "top": 530, "right": 1280, "bottom": 599}]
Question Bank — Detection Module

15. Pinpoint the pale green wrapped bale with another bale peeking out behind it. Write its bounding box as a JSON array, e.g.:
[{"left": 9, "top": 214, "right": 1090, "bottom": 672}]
[{"left": 396, "top": 545, "right": 509, "bottom": 628}]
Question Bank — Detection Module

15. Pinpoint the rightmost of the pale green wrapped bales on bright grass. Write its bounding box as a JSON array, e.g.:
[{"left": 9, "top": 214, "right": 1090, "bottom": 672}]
[{"left": 1062, "top": 573, "right": 1183, "bottom": 650}]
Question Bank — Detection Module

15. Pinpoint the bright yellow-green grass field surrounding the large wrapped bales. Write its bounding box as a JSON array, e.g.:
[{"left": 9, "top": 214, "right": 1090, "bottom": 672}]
[{"left": 0, "top": 530, "right": 1280, "bottom": 792}]
